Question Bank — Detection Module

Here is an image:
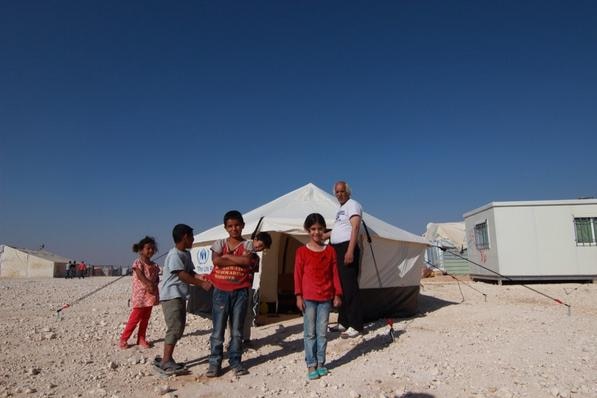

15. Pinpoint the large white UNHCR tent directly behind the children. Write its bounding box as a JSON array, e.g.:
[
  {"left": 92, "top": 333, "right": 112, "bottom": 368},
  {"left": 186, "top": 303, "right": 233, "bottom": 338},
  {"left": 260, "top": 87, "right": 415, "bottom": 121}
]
[{"left": 189, "top": 183, "right": 429, "bottom": 320}]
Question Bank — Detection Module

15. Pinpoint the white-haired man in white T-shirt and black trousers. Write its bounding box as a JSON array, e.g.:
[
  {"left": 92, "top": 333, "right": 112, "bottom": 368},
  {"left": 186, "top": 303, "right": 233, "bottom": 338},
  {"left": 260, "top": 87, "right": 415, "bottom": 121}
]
[{"left": 324, "top": 181, "right": 363, "bottom": 338}]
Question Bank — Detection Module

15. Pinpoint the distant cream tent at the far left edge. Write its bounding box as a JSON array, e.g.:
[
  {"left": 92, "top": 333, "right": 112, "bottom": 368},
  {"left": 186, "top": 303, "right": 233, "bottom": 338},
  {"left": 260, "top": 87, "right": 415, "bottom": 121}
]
[{"left": 0, "top": 245, "right": 70, "bottom": 278}]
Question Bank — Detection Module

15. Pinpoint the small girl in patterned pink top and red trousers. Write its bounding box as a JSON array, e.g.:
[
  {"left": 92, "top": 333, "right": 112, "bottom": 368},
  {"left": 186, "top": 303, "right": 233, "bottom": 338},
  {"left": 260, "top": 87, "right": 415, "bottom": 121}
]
[{"left": 118, "top": 236, "right": 159, "bottom": 349}]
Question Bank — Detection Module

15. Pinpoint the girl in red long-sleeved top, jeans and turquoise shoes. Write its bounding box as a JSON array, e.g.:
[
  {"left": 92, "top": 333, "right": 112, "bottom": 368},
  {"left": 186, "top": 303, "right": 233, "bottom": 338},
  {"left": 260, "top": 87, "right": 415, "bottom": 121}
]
[{"left": 294, "top": 213, "right": 342, "bottom": 380}]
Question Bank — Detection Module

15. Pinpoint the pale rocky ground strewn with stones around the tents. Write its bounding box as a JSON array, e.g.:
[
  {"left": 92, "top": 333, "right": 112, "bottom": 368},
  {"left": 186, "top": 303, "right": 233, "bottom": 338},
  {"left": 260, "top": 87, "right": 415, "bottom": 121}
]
[{"left": 0, "top": 277, "right": 597, "bottom": 398}]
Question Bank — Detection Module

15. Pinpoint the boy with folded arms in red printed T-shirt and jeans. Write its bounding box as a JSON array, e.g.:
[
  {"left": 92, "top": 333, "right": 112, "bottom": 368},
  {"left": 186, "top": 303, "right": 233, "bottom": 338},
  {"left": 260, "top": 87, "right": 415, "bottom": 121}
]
[{"left": 205, "top": 210, "right": 253, "bottom": 377}]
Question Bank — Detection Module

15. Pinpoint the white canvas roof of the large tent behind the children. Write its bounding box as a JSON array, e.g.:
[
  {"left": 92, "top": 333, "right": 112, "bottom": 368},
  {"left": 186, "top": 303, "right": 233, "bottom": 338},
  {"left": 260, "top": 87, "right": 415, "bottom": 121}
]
[{"left": 195, "top": 183, "right": 429, "bottom": 245}]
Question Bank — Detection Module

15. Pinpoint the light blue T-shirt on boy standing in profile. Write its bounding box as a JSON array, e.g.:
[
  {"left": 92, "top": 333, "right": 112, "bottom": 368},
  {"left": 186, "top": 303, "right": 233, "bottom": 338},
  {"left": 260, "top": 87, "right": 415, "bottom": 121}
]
[{"left": 160, "top": 247, "right": 195, "bottom": 301}]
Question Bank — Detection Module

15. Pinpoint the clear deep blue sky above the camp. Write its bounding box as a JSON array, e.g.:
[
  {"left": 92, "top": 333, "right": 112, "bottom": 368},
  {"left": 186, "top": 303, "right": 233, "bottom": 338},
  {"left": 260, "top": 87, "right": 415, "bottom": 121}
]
[{"left": 0, "top": 0, "right": 597, "bottom": 265}]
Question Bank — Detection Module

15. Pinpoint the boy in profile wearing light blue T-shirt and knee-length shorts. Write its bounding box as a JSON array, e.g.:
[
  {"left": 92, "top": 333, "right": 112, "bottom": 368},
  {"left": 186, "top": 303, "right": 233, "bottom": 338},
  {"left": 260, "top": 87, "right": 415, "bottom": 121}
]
[{"left": 158, "top": 224, "right": 211, "bottom": 374}]
